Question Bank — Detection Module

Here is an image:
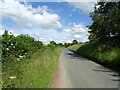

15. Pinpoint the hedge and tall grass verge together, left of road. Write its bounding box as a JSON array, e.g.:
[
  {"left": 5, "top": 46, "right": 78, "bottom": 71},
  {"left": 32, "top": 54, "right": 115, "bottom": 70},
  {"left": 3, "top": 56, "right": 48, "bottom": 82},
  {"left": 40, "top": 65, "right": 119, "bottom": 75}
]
[{"left": 0, "top": 31, "right": 63, "bottom": 88}]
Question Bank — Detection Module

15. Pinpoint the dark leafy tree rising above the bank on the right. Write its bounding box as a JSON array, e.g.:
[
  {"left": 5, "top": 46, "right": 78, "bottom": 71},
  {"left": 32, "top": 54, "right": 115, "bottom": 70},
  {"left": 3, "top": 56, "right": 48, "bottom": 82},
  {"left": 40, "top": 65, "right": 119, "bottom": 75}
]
[{"left": 89, "top": 1, "right": 120, "bottom": 46}]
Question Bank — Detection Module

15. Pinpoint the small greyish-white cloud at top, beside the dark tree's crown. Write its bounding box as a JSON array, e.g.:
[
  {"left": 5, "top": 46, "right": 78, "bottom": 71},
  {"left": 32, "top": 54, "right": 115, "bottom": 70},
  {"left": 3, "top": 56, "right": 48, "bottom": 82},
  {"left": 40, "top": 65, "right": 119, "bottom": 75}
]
[{"left": 69, "top": 0, "right": 97, "bottom": 13}]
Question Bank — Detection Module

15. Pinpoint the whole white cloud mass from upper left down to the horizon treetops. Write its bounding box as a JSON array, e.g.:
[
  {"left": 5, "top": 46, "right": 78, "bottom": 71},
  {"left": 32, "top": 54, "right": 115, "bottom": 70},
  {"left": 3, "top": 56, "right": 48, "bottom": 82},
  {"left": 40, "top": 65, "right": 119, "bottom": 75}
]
[{"left": 0, "top": 0, "right": 90, "bottom": 44}]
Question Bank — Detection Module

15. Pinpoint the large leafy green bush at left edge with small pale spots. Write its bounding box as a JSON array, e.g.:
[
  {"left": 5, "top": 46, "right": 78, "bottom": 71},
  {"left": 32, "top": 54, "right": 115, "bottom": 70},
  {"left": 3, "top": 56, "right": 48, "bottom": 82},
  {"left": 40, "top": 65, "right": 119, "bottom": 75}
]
[{"left": 2, "top": 30, "right": 43, "bottom": 61}]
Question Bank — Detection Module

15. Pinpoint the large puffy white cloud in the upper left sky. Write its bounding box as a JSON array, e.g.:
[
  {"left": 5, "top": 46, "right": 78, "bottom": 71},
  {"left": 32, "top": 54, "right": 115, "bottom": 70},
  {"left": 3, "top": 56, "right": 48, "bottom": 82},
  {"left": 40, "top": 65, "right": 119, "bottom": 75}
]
[{"left": 0, "top": 0, "right": 62, "bottom": 29}]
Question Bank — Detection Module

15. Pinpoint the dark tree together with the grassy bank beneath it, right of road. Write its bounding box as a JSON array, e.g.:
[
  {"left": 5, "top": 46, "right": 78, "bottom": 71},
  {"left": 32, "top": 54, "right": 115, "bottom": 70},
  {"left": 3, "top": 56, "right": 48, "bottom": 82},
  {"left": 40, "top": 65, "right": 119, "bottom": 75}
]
[{"left": 69, "top": 2, "right": 120, "bottom": 71}]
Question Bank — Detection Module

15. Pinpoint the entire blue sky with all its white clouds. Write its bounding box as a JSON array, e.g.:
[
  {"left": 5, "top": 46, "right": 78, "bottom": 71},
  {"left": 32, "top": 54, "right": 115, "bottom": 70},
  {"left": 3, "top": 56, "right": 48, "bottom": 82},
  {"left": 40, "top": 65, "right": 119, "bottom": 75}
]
[{"left": 0, "top": 0, "right": 96, "bottom": 44}]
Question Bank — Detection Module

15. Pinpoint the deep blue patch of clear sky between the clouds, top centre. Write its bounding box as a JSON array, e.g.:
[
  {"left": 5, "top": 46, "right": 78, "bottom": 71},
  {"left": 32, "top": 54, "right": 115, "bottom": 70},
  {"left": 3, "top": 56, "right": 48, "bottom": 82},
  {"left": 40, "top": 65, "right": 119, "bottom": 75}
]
[{"left": 28, "top": 2, "right": 91, "bottom": 26}]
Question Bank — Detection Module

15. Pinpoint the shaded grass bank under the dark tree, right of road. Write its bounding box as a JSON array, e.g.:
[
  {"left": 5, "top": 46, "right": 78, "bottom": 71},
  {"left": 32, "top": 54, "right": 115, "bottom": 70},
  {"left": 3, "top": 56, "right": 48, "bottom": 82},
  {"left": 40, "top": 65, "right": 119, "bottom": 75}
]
[{"left": 69, "top": 42, "right": 120, "bottom": 71}]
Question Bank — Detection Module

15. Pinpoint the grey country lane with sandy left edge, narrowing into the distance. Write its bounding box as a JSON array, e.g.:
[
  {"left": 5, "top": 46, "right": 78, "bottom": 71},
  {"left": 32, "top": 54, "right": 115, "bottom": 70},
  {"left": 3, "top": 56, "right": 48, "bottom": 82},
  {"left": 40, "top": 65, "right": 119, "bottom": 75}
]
[{"left": 51, "top": 49, "right": 119, "bottom": 88}]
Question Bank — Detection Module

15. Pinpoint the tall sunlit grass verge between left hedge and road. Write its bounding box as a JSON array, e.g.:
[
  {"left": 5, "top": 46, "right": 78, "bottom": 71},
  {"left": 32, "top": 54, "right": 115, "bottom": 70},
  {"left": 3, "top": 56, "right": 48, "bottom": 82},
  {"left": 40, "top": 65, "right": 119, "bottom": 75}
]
[{"left": 2, "top": 47, "right": 62, "bottom": 88}]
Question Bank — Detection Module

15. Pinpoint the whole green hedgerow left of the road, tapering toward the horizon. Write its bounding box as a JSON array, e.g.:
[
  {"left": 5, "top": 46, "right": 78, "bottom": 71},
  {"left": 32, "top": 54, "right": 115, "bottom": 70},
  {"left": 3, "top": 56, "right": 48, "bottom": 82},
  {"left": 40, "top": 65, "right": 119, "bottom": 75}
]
[{"left": 1, "top": 30, "right": 64, "bottom": 63}]
